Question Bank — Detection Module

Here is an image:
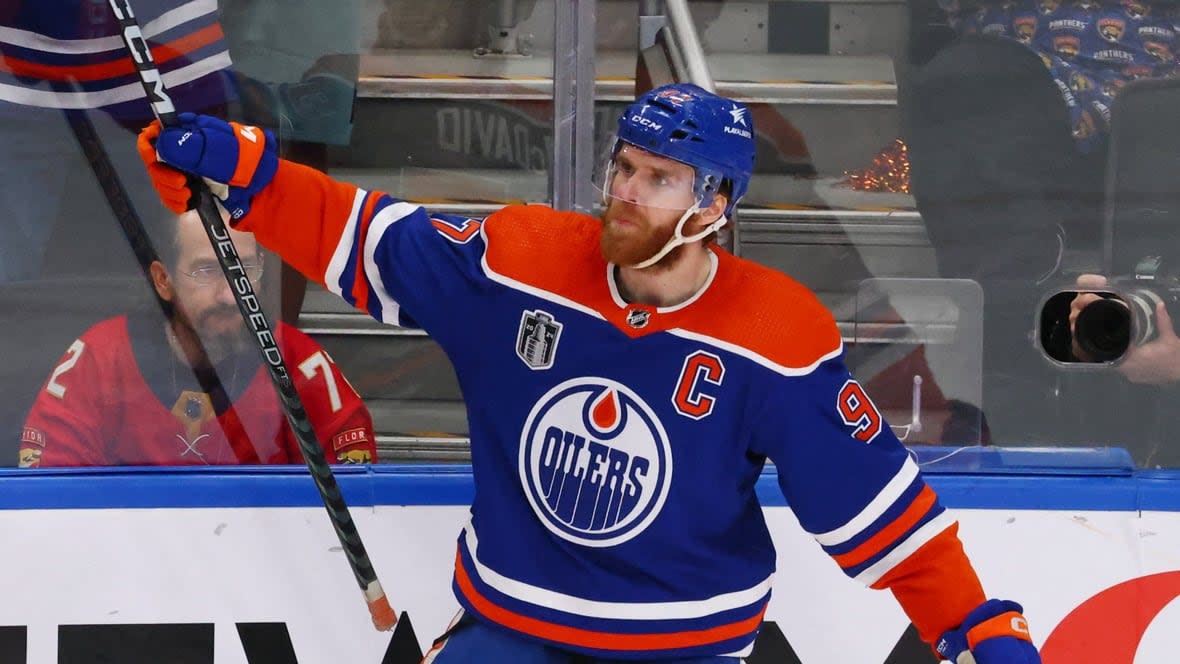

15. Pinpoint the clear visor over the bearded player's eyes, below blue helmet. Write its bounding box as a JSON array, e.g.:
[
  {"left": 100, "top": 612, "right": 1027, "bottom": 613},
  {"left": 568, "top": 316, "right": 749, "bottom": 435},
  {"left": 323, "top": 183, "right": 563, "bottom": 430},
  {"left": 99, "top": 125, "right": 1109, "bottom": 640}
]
[{"left": 595, "top": 144, "right": 697, "bottom": 211}]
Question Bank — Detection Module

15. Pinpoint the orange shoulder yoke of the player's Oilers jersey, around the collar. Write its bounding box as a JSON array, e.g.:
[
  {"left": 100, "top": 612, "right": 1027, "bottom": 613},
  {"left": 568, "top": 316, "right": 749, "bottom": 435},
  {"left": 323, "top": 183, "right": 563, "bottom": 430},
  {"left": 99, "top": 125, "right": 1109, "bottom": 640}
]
[{"left": 471, "top": 205, "right": 843, "bottom": 370}]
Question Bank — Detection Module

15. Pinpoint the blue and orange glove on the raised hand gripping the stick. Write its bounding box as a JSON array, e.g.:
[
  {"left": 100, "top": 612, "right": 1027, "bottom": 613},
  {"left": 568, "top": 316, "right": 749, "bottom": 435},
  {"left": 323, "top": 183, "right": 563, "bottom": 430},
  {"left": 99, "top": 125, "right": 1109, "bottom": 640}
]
[{"left": 138, "top": 113, "right": 278, "bottom": 219}]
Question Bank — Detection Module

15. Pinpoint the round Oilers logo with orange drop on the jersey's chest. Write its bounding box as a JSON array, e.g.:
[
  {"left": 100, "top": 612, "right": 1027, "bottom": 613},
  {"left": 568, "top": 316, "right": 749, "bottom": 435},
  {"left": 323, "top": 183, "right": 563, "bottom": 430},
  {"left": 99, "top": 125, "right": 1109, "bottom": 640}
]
[{"left": 520, "top": 377, "right": 673, "bottom": 547}]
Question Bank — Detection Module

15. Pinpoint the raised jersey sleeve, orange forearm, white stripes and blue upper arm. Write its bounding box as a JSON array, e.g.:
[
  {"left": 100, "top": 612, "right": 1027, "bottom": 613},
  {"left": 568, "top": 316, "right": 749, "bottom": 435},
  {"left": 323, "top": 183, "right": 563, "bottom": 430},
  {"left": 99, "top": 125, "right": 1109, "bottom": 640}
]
[{"left": 238, "top": 160, "right": 489, "bottom": 335}]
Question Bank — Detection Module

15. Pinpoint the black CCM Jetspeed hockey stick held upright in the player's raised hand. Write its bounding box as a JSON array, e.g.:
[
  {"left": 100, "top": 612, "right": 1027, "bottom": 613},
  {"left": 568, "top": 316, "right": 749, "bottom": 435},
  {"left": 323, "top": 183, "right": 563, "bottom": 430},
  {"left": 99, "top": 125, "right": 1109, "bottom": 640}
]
[{"left": 109, "top": 0, "right": 398, "bottom": 631}]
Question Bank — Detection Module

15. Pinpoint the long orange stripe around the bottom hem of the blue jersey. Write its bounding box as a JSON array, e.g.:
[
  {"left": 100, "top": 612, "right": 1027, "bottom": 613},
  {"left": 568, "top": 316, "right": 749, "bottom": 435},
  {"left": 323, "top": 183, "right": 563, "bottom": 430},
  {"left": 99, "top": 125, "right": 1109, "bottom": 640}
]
[{"left": 454, "top": 554, "right": 766, "bottom": 651}]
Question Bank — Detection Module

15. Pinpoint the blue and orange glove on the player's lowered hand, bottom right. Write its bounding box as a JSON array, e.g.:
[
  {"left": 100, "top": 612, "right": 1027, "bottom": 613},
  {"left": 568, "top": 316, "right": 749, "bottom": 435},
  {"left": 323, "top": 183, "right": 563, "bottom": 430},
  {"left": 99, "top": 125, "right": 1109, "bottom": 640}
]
[{"left": 935, "top": 599, "right": 1041, "bottom": 664}]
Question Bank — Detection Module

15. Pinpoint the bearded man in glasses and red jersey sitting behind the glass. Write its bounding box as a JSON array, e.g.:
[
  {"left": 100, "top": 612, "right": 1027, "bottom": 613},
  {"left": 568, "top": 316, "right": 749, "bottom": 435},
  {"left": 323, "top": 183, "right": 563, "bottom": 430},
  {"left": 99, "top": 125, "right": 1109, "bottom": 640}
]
[{"left": 20, "top": 212, "right": 376, "bottom": 467}]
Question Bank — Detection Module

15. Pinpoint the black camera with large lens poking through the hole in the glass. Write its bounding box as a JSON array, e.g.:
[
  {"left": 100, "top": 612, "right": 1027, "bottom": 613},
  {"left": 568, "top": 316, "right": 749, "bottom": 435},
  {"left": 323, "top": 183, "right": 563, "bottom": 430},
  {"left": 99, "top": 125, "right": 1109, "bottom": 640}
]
[{"left": 1074, "top": 256, "right": 1180, "bottom": 362}]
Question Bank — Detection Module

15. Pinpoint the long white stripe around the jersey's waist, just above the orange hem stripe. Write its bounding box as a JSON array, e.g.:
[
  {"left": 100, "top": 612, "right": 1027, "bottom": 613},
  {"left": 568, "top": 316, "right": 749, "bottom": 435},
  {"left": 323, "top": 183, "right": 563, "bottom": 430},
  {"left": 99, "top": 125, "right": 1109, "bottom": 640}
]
[{"left": 464, "top": 521, "right": 773, "bottom": 620}]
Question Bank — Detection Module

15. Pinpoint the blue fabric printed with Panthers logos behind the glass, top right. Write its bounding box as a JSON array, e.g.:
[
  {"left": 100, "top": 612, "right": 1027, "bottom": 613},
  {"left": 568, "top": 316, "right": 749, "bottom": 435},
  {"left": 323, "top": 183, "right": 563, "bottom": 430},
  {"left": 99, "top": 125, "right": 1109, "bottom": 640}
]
[{"left": 939, "top": 0, "right": 1180, "bottom": 153}]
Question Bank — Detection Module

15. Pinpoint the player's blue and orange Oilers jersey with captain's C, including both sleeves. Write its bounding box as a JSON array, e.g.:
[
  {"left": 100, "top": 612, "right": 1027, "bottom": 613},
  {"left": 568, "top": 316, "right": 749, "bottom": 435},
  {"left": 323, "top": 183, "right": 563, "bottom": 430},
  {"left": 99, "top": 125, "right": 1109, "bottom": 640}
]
[{"left": 240, "top": 162, "right": 984, "bottom": 659}]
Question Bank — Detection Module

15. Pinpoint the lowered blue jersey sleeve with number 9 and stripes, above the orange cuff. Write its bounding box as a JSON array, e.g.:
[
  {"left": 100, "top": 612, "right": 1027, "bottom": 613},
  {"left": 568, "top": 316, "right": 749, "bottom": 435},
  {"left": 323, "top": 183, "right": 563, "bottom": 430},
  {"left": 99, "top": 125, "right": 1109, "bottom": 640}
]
[{"left": 755, "top": 354, "right": 952, "bottom": 585}]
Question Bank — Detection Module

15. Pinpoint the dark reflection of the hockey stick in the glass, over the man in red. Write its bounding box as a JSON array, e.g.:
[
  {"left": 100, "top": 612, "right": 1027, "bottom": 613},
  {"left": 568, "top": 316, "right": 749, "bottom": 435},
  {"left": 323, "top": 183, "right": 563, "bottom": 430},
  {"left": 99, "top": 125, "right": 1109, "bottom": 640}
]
[{"left": 65, "top": 110, "right": 258, "bottom": 464}]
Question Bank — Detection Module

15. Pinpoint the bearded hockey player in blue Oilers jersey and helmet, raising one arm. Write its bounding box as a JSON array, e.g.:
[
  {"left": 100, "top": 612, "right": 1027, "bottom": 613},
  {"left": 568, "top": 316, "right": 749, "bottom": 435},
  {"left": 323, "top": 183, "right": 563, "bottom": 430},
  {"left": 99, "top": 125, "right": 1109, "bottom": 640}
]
[{"left": 139, "top": 85, "right": 1040, "bottom": 664}]
